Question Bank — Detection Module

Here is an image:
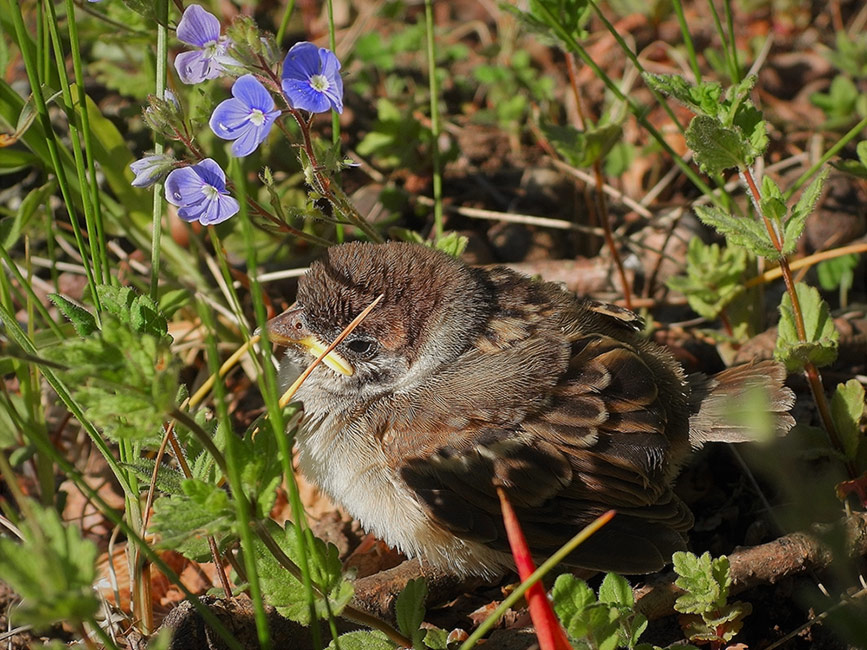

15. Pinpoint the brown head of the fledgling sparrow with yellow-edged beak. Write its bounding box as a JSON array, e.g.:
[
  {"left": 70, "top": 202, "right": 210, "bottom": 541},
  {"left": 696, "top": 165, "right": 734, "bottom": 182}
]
[{"left": 268, "top": 242, "right": 492, "bottom": 398}]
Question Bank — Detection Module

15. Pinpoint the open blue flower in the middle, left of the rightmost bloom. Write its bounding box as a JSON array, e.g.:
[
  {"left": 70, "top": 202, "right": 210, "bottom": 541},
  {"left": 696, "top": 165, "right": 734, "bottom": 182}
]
[{"left": 208, "top": 74, "right": 280, "bottom": 157}]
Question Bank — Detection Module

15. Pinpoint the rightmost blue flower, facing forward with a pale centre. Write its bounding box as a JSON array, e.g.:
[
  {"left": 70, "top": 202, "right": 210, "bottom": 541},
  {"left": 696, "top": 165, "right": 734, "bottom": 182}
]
[{"left": 281, "top": 41, "right": 343, "bottom": 113}]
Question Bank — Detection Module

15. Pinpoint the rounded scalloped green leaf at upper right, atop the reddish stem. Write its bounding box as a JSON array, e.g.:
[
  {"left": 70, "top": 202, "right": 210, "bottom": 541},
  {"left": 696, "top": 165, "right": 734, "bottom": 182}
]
[{"left": 686, "top": 115, "right": 755, "bottom": 175}]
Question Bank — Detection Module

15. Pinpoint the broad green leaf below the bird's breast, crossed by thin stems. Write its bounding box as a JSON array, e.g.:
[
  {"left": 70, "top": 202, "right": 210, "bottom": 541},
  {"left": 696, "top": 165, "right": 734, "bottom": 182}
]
[{"left": 254, "top": 520, "right": 353, "bottom": 620}]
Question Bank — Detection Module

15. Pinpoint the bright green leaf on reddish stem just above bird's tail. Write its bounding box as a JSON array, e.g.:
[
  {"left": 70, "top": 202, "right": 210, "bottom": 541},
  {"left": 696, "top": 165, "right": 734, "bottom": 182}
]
[{"left": 774, "top": 282, "right": 839, "bottom": 372}]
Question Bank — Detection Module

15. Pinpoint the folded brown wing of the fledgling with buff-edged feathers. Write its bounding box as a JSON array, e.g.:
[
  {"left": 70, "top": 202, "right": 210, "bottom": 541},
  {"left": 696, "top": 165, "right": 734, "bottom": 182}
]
[{"left": 380, "top": 334, "right": 692, "bottom": 573}]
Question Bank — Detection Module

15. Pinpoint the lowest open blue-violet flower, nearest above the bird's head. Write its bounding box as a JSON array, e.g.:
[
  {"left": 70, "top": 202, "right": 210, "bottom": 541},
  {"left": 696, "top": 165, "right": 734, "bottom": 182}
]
[{"left": 166, "top": 158, "right": 240, "bottom": 226}]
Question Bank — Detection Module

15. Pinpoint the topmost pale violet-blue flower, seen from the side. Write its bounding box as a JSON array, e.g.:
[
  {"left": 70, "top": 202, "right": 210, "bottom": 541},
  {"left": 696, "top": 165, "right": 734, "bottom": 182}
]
[{"left": 175, "top": 5, "right": 237, "bottom": 84}]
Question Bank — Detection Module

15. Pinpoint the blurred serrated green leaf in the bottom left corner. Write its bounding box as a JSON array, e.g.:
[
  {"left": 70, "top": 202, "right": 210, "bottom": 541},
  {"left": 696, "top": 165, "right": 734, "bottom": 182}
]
[{"left": 0, "top": 502, "right": 99, "bottom": 629}]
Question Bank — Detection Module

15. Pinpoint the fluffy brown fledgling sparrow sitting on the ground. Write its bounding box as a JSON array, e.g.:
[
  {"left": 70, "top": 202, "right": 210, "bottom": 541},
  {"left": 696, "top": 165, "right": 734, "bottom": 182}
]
[{"left": 266, "top": 242, "right": 794, "bottom": 580}]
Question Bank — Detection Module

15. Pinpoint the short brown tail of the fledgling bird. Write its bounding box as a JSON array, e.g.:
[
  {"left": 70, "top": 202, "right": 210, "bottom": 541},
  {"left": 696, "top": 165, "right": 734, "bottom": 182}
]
[{"left": 689, "top": 360, "right": 795, "bottom": 448}]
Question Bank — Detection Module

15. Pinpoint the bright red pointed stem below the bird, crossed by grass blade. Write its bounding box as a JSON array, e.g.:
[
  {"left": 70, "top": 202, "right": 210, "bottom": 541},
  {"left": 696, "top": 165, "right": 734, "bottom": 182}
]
[{"left": 497, "top": 487, "right": 572, "bottom": 650}]
